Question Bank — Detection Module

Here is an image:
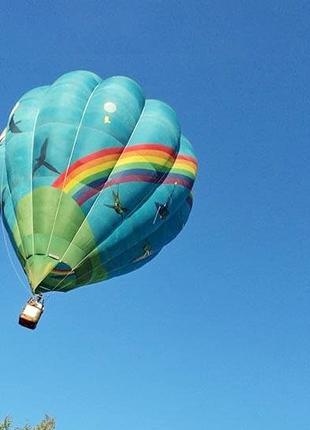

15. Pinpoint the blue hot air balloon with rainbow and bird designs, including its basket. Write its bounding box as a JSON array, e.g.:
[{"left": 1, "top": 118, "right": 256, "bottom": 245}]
[{"left": 0, "top": 71, "right": 197, "bottom": 328}]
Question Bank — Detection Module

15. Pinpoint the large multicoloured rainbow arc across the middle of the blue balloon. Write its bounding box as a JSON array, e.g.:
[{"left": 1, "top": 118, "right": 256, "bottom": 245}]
[{"left": 53, "top": 143, "right": 197, "bottom": 205}]
